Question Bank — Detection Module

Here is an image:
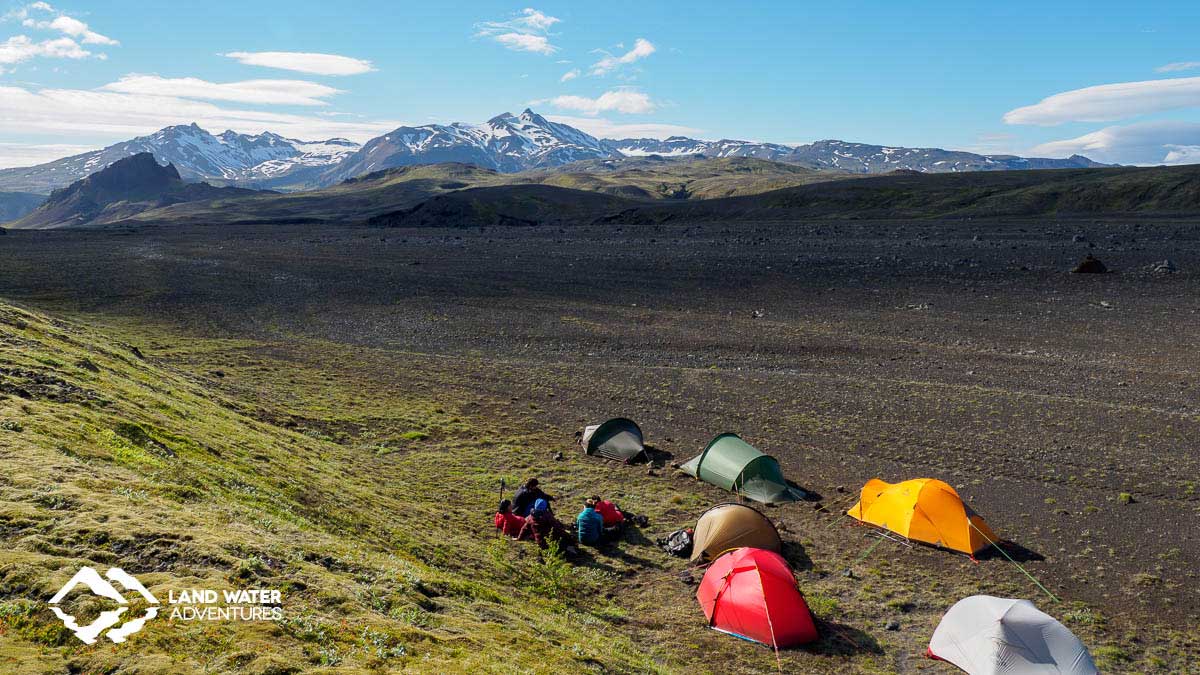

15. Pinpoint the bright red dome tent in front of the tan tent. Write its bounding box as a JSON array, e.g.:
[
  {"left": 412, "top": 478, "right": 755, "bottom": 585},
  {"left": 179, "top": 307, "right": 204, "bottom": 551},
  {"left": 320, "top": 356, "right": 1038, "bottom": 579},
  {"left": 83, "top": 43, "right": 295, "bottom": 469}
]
[{"left": 696, "top": 540, "right": 817, "bottom": 649}]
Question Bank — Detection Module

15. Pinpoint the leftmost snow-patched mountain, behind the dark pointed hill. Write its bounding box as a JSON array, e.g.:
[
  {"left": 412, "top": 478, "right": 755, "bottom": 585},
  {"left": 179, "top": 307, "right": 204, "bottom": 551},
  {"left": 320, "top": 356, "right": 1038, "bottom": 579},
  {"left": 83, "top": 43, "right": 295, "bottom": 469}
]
[{"left": 0, "top": 124, "right": 359, "bottom": 192}]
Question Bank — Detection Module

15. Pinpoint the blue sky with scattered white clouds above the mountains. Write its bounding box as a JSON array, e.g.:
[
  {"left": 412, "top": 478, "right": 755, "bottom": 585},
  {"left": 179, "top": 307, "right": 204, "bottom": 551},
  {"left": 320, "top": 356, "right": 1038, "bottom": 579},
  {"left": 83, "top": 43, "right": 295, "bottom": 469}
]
[{"left": 0, "top": 0, "right": 1200, "bottom": 166}]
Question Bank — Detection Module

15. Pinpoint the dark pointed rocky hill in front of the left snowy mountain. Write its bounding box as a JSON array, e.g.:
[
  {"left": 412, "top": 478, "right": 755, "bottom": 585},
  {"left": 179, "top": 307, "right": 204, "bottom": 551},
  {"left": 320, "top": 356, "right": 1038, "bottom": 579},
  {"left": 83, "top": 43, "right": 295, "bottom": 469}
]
[{"left": 11, "top": 153, "right": 264, "bottom": 229}]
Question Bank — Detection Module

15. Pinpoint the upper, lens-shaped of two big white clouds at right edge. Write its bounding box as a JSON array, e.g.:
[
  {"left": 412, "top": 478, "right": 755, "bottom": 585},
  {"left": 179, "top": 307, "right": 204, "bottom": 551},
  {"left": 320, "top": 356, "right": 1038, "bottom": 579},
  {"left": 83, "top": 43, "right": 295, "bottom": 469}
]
[{"left": 1004, "top": 77, "right": 1200, "bottom": 126}]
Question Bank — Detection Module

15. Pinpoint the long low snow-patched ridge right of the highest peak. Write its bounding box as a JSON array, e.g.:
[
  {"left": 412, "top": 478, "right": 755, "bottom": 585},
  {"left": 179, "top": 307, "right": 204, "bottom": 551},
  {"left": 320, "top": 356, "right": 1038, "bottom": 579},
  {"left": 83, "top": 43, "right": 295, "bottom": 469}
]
[{"left": 605, "top": 136, "right": 1106, "bottom": 173}]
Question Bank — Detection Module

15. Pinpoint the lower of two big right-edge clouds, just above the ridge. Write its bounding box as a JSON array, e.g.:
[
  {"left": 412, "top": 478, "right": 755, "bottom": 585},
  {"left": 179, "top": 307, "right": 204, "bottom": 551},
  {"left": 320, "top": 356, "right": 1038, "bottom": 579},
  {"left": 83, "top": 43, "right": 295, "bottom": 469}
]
[{"left": 1032, "top": 121, "right": 1200, "bottom": 165}]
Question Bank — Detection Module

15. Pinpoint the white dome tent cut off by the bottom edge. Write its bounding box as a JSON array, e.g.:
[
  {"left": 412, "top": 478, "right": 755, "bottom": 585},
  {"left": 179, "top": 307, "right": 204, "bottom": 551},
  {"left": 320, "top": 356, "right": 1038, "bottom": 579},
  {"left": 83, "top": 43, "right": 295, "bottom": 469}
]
[{"left": 929, "top": 596, "right": 1099, "bottom": 675}]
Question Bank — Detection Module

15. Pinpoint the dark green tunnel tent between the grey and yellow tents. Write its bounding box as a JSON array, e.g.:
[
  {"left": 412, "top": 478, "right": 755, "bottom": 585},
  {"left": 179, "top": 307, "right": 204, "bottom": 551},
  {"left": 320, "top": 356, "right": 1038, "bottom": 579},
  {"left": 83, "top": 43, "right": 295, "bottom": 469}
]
[{"left": 679, "top": 434, "right": 804, "bottom": 504}]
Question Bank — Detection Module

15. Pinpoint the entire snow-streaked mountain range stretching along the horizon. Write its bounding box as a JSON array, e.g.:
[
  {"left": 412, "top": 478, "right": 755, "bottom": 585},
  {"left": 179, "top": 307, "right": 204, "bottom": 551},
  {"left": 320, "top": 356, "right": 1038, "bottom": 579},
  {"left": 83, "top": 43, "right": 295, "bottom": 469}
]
[{"left": 0, "top": 109, "right": 1105, "bottom": 195}]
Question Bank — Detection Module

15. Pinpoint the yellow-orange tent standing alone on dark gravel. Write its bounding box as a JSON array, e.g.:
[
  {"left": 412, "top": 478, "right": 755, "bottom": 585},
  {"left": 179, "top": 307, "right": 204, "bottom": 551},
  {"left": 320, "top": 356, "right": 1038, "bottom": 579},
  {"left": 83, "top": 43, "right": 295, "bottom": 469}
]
[{"left": 846, "top": 478, "right": 998, "bottom": 555}]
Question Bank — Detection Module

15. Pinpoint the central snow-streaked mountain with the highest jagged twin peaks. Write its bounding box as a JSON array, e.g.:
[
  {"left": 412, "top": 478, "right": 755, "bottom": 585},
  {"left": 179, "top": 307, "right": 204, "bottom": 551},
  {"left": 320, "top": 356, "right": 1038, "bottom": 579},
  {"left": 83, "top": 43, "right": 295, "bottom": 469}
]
[{"left": 323, "top": 109, "right": 620, "bottom": 183}]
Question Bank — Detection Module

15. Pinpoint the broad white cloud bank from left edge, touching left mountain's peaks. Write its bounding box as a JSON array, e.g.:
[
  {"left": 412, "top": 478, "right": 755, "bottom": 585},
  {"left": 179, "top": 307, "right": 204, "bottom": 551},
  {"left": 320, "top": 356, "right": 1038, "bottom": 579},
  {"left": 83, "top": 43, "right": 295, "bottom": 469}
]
[{"left": 0, "top": 85, "right": 401, "bottom": 143}]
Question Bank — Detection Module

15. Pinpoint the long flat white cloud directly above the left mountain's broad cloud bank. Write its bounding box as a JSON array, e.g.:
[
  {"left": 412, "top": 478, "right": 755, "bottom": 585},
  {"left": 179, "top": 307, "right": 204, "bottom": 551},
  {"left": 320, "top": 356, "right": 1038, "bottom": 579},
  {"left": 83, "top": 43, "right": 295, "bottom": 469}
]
[{"left": 101, "top": 74, "right": 341, "bottom": 106}]
